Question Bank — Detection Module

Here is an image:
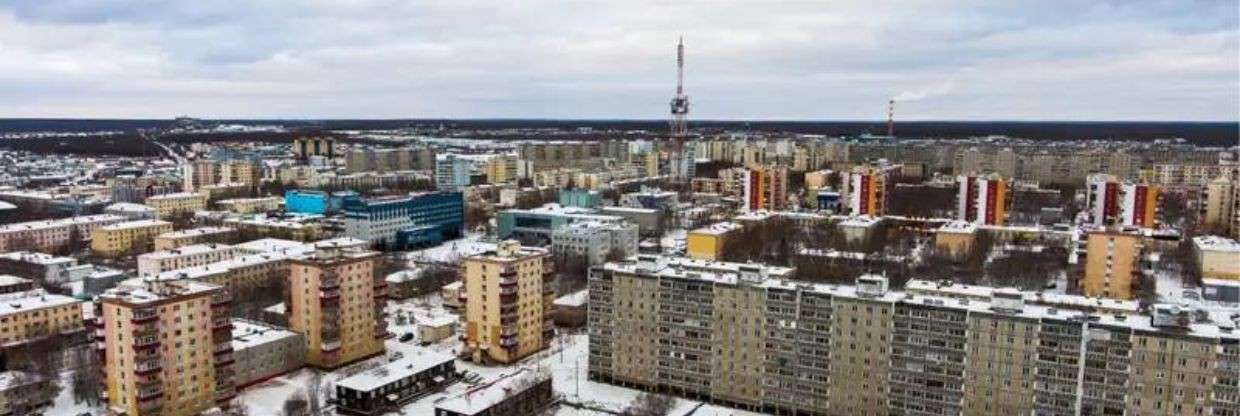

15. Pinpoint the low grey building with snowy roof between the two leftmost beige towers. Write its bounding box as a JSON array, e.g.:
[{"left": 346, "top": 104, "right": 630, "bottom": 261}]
[{"left": 232, "top": 319, "right": 306, "bottom": 387}]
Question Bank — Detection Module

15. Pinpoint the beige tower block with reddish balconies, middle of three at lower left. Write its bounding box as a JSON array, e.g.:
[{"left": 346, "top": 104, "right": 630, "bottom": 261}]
[{"left": 284, "top": 247, "right": 388, "bottom": 369}]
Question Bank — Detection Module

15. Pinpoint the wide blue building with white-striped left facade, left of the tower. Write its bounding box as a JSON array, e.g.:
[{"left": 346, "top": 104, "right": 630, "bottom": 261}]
[{"left": 343, "top": 192, "right": 465, "bottom": 250}]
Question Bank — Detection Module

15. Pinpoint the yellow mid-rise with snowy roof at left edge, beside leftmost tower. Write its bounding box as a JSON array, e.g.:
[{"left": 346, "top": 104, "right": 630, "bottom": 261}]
[{"left": 0, "top": 289, "right": 84, "bottom": 346}]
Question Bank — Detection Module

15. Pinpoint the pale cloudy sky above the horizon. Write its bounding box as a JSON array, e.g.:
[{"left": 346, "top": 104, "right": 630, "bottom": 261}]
[{"left": 0, "top": 0, "right": 1240, "bottom": 120}]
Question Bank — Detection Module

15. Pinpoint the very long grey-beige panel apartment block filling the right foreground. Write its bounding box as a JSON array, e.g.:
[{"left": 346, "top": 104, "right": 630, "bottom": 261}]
[{"left": 588, "top": 256, "right": 1240, "bottom": 415}]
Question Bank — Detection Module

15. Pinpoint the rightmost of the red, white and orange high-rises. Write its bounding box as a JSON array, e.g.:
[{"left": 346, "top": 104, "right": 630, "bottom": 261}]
[{"left": 1086, "top": 174, "right": 1159, "bottom": 228}]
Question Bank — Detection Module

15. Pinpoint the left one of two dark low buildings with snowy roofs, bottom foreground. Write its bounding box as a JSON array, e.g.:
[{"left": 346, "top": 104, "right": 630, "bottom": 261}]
[{"left": 336, "top": 351, "right": 459, "bottom": 416}]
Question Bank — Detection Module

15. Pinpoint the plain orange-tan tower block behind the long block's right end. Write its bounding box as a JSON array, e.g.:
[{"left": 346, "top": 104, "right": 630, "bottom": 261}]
[{"left": 1080, "top": 230, "right": 1142, "bottom": 299}]
